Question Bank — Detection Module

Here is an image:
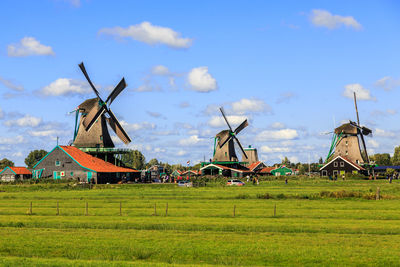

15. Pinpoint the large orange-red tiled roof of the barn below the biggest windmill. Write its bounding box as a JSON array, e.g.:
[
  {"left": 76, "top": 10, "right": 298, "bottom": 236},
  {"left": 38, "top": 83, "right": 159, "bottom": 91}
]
[{"left": 60, "top": 146, "right": 139, "bottom": 172}]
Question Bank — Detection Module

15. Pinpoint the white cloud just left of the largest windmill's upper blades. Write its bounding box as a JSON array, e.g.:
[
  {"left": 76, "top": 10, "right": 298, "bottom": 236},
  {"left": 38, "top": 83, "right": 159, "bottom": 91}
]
[{"left": 40, "top": 78, "right": 92, "bottom": 96}]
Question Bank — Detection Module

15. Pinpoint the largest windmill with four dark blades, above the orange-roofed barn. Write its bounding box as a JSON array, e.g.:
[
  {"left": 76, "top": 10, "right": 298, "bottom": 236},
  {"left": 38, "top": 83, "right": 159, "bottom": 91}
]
[{"left": 73, "top": 62, "right": 131, "bottom": 148}]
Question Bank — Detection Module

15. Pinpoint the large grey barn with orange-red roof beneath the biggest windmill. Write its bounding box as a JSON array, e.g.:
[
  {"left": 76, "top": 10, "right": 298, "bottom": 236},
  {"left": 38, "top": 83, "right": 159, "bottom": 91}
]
[{"left": 33, "top": 146, "right": 140, "bottom": 184}]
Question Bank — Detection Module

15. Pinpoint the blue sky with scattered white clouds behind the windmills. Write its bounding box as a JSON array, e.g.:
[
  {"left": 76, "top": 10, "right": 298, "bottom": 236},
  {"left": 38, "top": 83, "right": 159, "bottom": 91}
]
[{"left": 0, "top": 0, "right": 400, "bottom": 165}]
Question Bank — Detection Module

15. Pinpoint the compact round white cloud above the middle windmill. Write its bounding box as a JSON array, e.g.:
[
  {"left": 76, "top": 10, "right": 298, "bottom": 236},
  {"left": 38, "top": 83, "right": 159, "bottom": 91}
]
[{"left": 188, "top": 67, "right": 218, "bottom": 93}]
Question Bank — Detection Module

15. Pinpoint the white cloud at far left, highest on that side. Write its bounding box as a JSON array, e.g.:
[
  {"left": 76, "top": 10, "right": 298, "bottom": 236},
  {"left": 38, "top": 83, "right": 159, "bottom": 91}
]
[{"left": 7, "top": 37, "right": 55, "bottom": 57}]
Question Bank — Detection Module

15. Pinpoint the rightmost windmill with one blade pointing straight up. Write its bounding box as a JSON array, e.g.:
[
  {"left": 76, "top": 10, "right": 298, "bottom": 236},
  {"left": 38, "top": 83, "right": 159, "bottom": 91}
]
[{"left": 326, "top": 92, "right": 372, "bottom": 164}]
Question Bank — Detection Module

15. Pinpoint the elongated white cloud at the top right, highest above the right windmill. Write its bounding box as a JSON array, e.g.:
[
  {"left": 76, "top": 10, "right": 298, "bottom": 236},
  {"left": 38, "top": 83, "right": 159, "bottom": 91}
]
[{"left": 310, "top": 9, "right": 362, "bottom": 30}]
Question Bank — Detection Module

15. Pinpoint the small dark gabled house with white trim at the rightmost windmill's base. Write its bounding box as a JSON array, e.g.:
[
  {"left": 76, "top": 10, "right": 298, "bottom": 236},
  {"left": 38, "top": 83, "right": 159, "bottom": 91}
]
[{"left": 319, "top": 156, "right": 365, "bottom": 176}]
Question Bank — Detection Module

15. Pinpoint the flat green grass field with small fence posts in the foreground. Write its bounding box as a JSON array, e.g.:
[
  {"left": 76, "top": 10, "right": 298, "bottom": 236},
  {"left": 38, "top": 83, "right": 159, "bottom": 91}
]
[{"left": 0, "top": 179, "right": 400, "bottom": 266}]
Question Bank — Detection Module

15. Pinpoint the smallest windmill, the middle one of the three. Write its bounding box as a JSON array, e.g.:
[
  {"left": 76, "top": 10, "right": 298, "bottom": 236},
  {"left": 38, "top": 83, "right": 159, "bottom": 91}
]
[{"left": 213, "top": 107, "right": 249, "bottom": 162}]
